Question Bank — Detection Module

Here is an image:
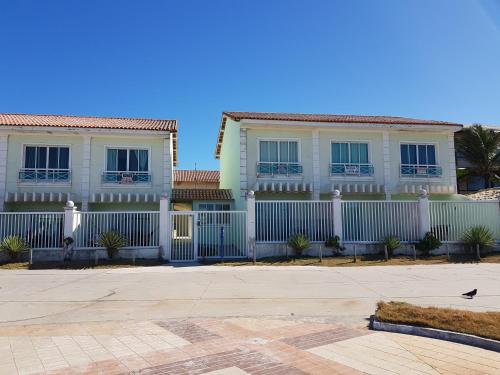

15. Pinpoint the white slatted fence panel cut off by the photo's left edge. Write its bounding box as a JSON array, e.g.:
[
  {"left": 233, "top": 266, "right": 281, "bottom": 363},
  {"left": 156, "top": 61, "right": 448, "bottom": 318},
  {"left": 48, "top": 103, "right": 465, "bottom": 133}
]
[{"left": 0, "top": 212, "right": 64, "bottom": 249}]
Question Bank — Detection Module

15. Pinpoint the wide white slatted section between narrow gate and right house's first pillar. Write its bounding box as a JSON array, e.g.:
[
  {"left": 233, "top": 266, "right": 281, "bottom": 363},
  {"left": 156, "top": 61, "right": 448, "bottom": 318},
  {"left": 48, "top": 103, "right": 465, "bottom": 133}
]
[{"left": 197, "top": 211, "right": 247, "bottom": 258}]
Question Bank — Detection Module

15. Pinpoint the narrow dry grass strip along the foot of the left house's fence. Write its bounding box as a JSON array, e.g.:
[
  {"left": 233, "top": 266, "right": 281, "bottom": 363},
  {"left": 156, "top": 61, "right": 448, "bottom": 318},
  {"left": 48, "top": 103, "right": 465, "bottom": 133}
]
[{"left": 0, "top": 259, "right": 165, "bottom": 270}]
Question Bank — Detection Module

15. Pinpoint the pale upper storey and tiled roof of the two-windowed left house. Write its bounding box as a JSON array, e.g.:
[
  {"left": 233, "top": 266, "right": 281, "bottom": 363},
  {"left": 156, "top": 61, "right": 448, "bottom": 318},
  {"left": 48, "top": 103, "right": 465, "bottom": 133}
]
[{"left": 0, "top": 114, "right": 177, "bottom": 211}]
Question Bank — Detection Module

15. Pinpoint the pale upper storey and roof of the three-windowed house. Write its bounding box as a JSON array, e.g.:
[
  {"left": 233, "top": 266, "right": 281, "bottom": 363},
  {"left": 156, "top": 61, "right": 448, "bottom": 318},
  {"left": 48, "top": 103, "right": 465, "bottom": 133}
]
[{"left": 215, "top": 112, "right": 462, "bottom": 209}]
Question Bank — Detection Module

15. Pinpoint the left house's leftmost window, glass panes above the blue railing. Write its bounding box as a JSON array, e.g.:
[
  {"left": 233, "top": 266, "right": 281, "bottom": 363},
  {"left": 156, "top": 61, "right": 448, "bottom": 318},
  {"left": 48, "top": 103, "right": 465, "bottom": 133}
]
[{"left": 24, "top": 146, "right": 69, "bottom": 169}]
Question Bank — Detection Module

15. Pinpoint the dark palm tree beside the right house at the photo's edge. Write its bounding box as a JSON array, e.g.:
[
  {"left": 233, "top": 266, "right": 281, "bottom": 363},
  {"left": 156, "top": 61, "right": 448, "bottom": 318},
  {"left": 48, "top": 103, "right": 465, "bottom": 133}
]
[{"left": 457, "top": 124, "right": 500, "bottom": 189}]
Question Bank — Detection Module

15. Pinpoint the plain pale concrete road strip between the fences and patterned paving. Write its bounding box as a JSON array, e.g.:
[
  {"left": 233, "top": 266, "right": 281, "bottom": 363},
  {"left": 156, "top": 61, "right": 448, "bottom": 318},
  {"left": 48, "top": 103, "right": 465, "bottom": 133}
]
[{"left": 0, "top": 264, "right": 500, "bottom": 326}]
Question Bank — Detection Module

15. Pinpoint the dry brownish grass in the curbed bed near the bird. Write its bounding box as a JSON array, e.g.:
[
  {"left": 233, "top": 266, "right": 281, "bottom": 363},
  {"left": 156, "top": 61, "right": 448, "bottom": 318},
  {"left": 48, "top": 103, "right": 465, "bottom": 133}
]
[{"left": 375, "top": 302, "right": 500, "bottom": 340}]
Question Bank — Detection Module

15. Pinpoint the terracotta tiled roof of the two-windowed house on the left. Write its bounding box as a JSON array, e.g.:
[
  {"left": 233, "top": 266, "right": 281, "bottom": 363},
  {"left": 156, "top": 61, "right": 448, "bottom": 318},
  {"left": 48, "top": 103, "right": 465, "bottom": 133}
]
[{"left": 0, "top": 113, "right": 177, "bottom": 132}]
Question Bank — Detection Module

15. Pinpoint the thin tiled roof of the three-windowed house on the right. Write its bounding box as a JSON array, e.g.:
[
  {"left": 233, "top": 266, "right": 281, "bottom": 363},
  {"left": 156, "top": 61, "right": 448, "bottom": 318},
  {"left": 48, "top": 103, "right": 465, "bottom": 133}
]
[{"left": 215, "top": 112, "right": 463, "bottom": 159}]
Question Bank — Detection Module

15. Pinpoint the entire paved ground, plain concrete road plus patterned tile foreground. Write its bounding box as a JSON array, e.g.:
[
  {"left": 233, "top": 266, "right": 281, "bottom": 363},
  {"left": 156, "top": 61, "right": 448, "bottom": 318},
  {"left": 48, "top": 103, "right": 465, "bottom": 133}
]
[{"left": 0, "top": 264, "right": 500, "bottom": 375}]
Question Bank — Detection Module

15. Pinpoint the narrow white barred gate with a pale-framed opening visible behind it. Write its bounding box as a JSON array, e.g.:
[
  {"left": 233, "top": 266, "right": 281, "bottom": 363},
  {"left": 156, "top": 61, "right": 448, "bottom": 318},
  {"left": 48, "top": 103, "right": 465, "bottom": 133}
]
[{"left": 170, "top": 211, "right": 197, "bottom": 262}]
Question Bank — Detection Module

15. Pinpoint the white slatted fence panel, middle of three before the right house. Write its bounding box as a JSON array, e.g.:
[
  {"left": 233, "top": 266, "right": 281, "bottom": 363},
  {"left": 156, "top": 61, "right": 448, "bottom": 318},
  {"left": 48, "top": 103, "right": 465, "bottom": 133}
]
[{"left": 342, "top": 201, "right": 419, "bottom": 243}]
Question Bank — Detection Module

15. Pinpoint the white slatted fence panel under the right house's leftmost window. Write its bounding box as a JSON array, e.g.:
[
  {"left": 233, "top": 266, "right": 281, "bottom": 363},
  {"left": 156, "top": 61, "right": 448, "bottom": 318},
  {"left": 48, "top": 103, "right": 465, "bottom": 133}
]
[{"left": 255, "top": 201, "right": 334, "bottom": 242}]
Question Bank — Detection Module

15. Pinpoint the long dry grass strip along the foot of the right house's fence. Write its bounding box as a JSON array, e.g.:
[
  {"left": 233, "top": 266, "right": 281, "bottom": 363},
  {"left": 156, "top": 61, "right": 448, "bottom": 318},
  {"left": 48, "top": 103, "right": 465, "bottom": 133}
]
[{"left": 202, "top": 253, "right": 500, "bottom": 267}]
